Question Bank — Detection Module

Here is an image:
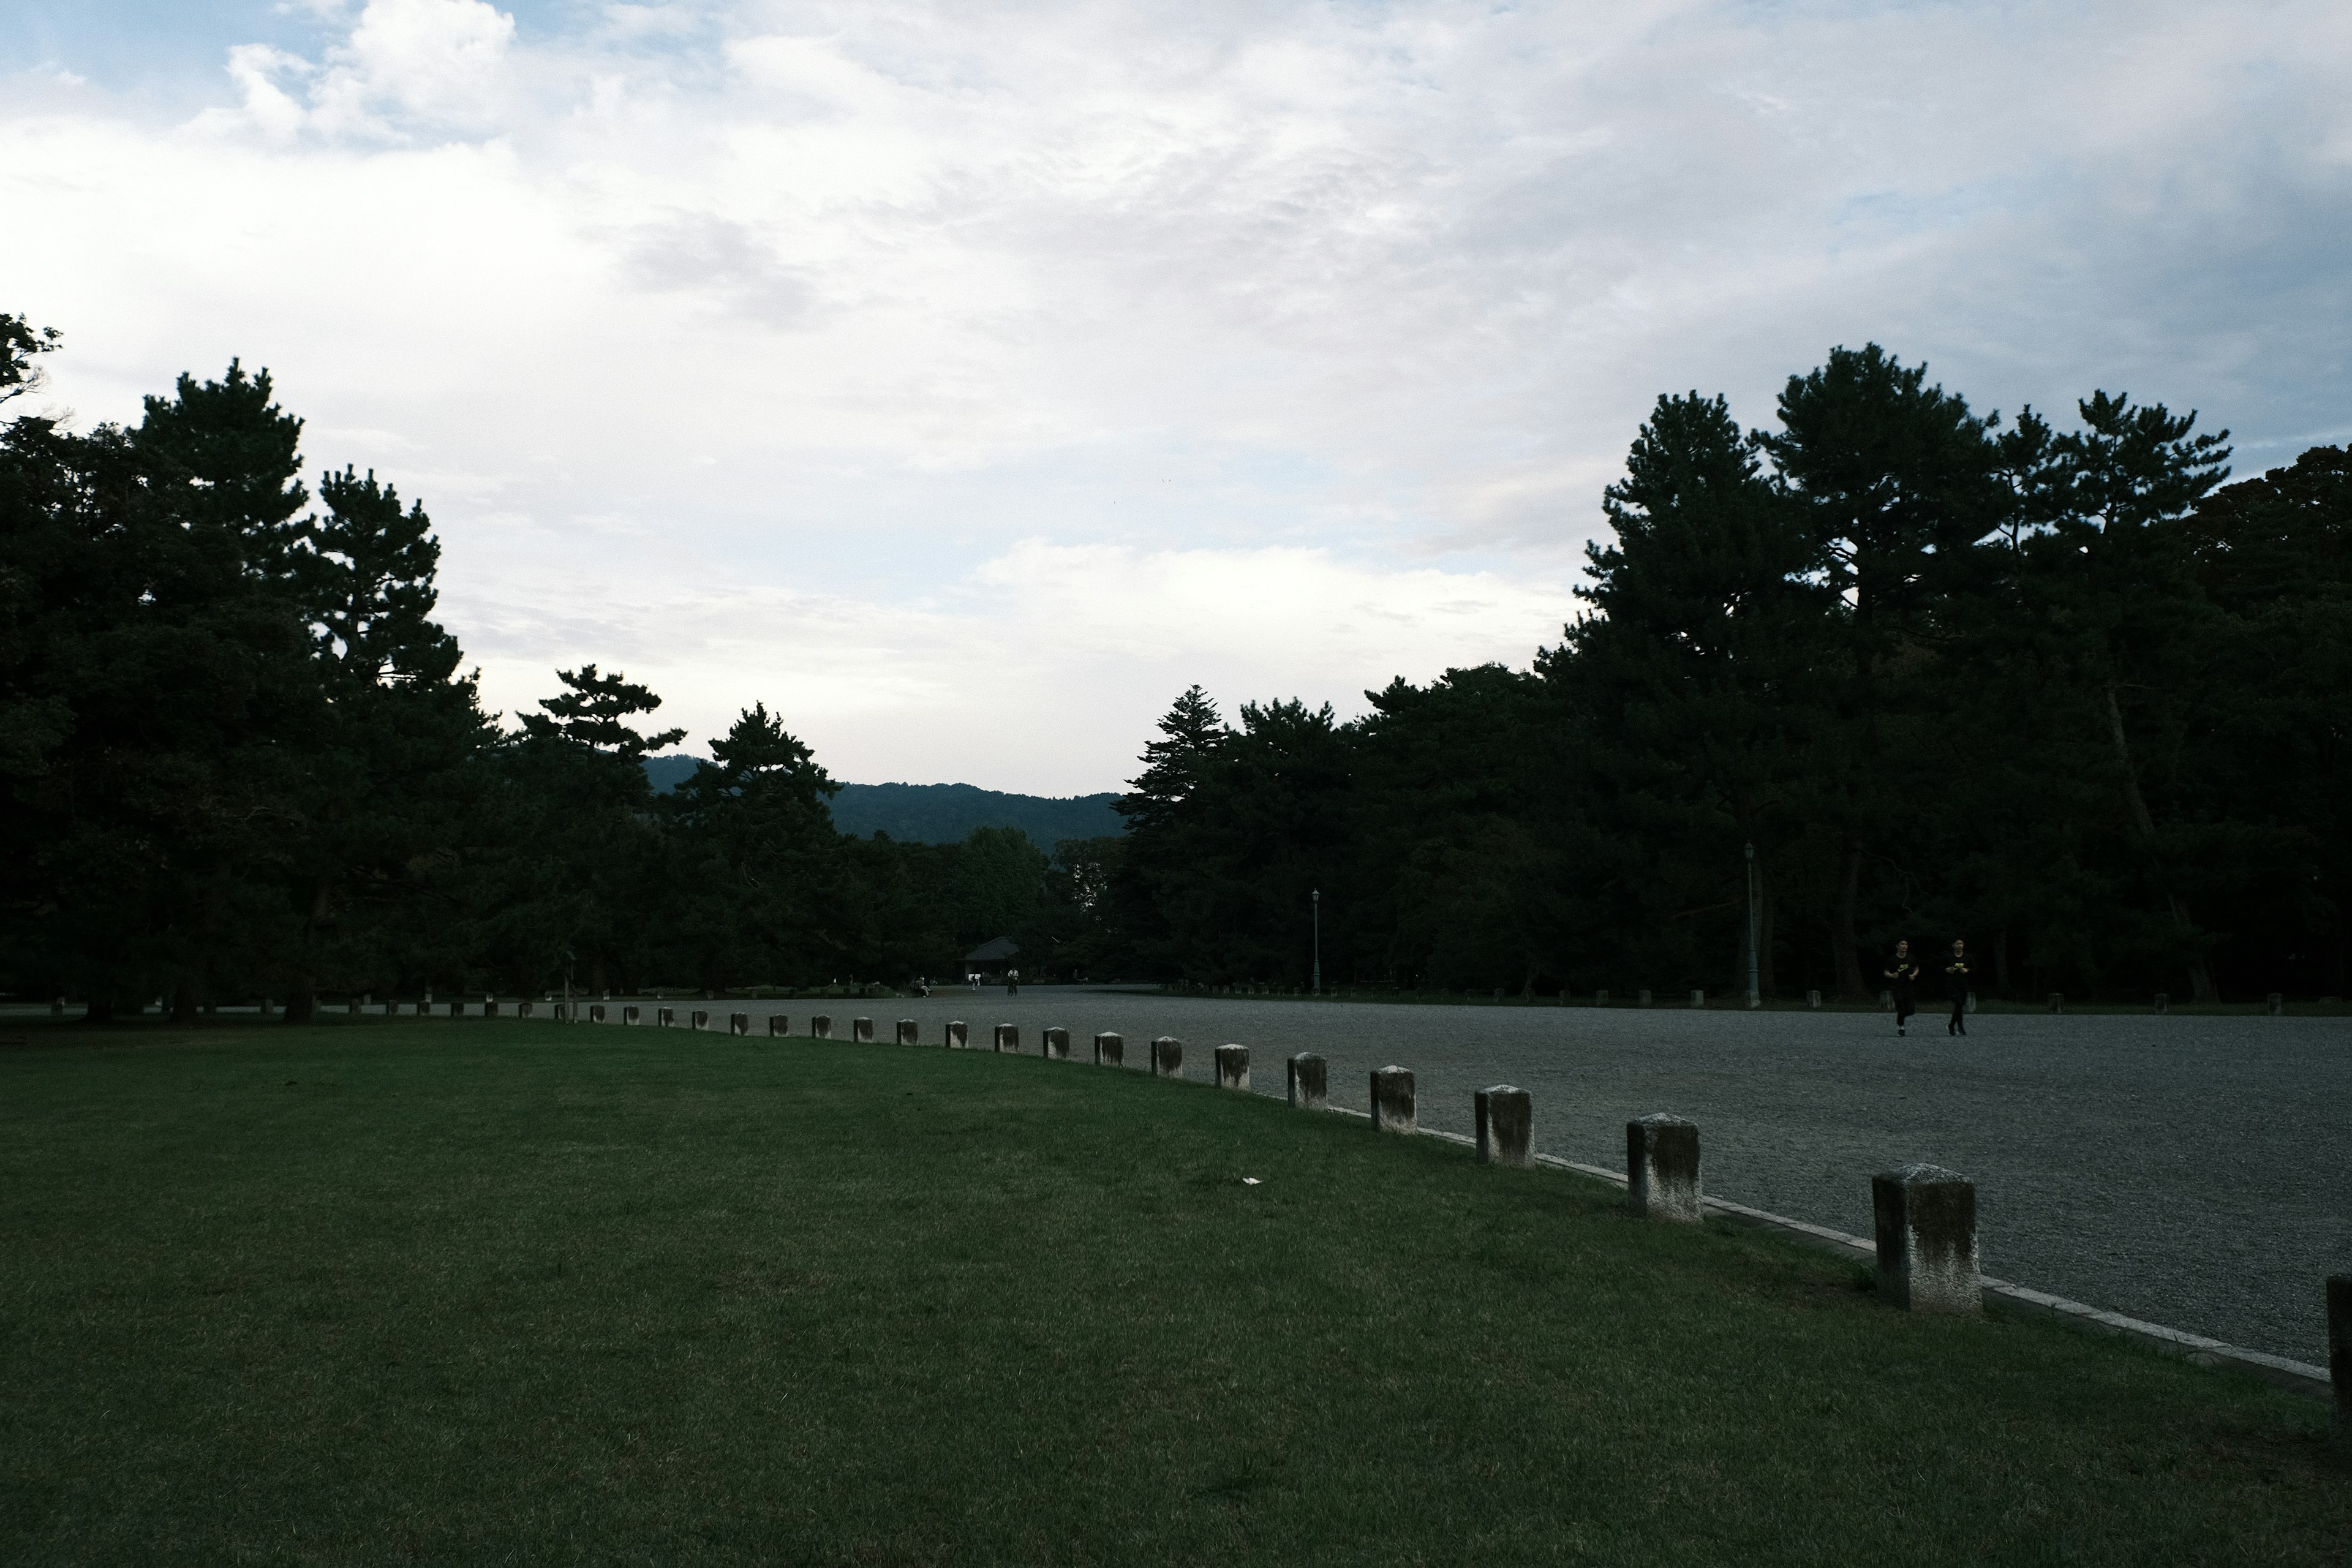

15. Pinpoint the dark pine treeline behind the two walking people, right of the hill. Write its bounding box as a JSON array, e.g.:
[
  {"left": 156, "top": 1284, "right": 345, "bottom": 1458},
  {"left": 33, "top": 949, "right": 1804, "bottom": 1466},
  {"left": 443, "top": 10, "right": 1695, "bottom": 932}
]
[{"left": 1089, "top": 345, "right": 2352, "bottom": 999}]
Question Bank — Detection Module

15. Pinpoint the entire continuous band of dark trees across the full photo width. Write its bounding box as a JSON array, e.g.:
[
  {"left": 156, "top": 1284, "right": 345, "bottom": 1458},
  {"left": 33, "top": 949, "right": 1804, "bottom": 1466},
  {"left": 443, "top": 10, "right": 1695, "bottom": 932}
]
[{"left": 0, "top": 315, "right": 2352, "bottom": 1018}]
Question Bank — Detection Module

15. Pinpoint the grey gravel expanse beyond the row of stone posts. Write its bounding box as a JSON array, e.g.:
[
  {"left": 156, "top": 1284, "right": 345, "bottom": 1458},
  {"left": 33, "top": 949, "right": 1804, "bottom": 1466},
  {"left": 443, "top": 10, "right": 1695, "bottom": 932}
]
[{"left": 832, "top": 987, "right": 2352, "bottom": 1366}]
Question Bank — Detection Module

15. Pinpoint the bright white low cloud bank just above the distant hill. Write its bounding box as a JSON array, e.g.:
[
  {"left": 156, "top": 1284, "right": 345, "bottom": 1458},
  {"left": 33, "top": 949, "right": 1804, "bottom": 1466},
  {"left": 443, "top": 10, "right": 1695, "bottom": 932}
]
[{"left": 445, "top": 538, "right": 1574, "bottom": 794}]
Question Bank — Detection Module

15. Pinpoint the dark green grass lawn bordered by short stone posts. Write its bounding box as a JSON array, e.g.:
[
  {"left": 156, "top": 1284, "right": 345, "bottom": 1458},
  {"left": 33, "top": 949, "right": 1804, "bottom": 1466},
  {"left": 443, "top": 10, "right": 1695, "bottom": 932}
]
[{"left": 0, "top": 1020, "right": 2352, "bottom": 1563}]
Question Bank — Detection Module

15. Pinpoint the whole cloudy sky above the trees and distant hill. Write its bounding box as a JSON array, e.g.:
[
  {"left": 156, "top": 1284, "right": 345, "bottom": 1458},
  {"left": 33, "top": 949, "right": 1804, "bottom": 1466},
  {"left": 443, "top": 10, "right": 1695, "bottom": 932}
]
[{"left": 0, "top": 0, "right": 2352, "bottom": 794}]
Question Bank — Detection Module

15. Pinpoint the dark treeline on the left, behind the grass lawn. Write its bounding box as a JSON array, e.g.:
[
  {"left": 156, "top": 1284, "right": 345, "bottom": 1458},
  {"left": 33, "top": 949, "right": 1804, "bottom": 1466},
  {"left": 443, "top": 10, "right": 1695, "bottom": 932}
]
[{"left": 0, "top": 315, "right": 1072, "bottom": 1018}]
